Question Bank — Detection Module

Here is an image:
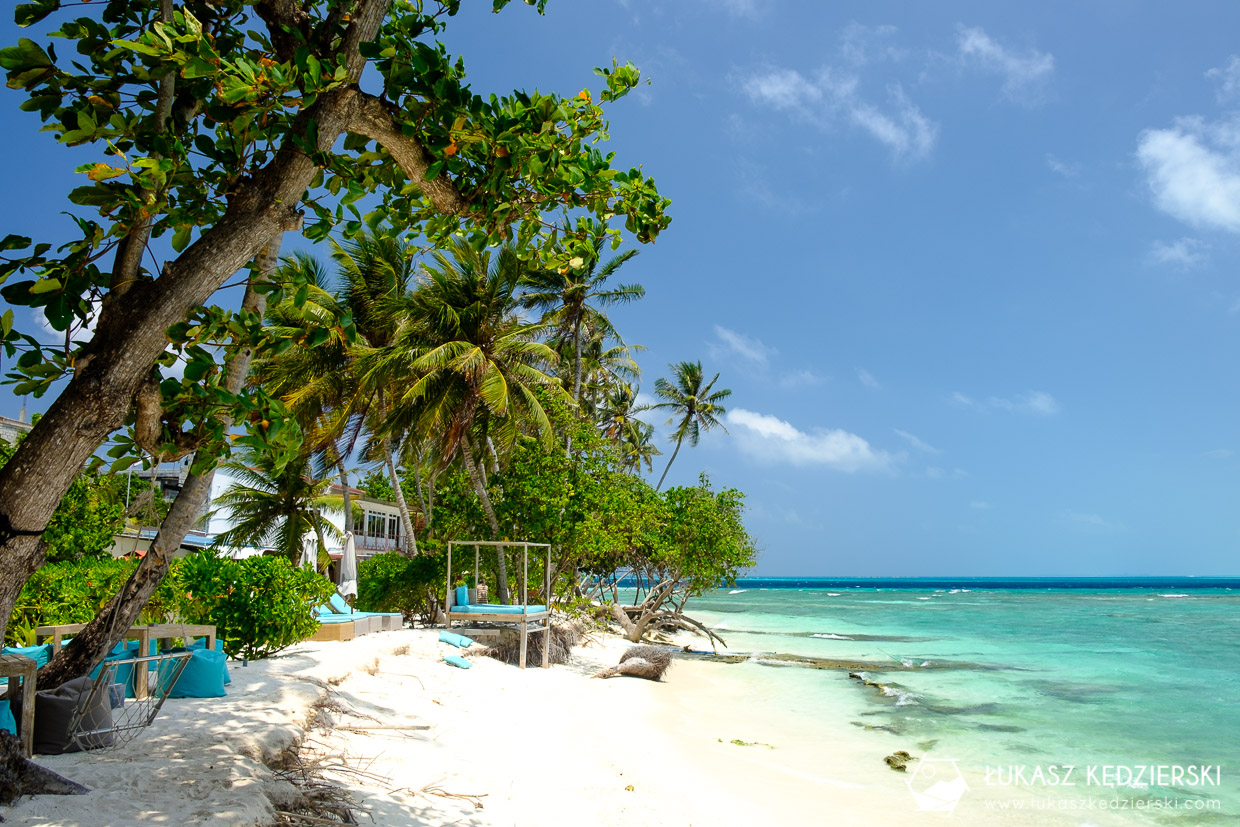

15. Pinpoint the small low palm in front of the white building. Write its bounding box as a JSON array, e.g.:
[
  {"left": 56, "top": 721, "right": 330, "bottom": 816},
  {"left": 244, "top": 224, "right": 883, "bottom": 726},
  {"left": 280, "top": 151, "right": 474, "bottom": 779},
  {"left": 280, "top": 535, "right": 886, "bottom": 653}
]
[{"left": 213, "top": 451, "right": 341, "bottom": 562}]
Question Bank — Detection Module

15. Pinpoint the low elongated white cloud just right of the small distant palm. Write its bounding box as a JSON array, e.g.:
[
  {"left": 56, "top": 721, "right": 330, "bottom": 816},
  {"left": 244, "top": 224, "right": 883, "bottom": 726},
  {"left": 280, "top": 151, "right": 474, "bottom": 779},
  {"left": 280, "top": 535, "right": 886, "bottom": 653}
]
[{"left": 727, "top": 408, "right": 897, "bottom": 472}]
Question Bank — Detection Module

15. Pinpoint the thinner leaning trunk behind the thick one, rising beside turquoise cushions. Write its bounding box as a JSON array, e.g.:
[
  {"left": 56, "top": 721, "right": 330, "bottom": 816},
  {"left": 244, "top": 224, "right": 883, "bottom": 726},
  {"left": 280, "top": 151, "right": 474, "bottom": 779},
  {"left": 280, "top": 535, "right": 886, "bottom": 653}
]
[{"left": 37, "top": 233, "right": 283, "bottom": 689}]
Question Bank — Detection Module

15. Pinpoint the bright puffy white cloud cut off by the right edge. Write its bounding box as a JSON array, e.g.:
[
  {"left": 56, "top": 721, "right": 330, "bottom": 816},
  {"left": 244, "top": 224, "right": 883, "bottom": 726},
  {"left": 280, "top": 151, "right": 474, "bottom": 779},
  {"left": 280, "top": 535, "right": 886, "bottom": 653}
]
[{"left": 1137, "top": 118, "right": 1240, "bottom": 232}]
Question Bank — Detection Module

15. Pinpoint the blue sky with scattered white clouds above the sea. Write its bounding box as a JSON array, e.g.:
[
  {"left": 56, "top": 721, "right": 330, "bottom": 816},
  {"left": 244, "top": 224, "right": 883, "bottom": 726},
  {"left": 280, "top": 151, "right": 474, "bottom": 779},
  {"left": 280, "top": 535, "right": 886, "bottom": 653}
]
[{"left": 0, "top": 0, "right": 1240, "bottom": 577}]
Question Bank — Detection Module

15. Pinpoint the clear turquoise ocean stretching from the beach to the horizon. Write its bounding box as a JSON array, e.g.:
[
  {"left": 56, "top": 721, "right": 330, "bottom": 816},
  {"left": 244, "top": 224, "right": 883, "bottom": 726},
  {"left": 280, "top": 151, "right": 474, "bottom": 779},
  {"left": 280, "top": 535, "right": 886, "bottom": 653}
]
[{"left": 687, "top": 578, "right": 1240, "bottom": 825}]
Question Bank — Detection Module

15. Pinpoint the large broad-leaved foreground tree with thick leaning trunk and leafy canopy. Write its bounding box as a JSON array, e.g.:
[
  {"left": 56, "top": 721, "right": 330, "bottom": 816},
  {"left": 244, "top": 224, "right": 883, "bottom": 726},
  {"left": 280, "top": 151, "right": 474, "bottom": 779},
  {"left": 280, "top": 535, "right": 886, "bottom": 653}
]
[{"left": 0, "top": 0, "right": 670, "bottom": 644}]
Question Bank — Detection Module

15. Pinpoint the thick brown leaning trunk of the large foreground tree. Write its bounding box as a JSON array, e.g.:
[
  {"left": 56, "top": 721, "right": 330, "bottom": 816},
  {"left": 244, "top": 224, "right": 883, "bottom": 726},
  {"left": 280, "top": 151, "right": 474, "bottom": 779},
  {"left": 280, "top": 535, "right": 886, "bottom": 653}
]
[{"left": 0, "top": 0, "right": 396, "bottom": 634}]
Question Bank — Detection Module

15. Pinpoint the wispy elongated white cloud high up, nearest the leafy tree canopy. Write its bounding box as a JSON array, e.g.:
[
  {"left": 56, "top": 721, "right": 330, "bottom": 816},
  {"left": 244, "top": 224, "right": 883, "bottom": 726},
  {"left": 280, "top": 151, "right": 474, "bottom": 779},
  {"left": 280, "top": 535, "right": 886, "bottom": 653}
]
[{"left": 740, "top": 66, "right": 939, "bottom": 161}]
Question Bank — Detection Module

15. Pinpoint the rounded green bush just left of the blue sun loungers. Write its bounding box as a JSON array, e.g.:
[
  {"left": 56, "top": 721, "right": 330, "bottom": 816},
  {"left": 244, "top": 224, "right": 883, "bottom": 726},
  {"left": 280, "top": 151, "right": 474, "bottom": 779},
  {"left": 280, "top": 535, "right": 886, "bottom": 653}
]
[{"left": 171, "top": 552, "right": 335, "bottom": 658}]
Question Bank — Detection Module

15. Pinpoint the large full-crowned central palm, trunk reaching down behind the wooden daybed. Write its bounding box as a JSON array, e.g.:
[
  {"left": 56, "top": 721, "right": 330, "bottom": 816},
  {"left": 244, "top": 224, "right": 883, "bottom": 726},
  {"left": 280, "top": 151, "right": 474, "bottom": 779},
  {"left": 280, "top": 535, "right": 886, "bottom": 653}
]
[{"left": 367, "top": 242, "right": 567, "bottom": 603}]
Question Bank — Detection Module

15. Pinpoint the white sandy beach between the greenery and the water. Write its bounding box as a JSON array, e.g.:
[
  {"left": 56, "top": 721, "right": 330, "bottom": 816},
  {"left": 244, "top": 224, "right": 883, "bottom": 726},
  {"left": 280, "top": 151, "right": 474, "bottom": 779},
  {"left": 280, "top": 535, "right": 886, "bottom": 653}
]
[{"left": 2, "top": 629, "right": 1140, "bottom": 827}]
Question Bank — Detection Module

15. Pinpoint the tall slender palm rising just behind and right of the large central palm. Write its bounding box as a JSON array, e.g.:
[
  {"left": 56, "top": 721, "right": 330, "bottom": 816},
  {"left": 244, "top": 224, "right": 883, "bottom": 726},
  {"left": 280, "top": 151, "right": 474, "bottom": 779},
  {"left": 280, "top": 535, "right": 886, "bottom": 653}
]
[{"left": 521, "top": 224, "right": 646, "bottom": 402}]
